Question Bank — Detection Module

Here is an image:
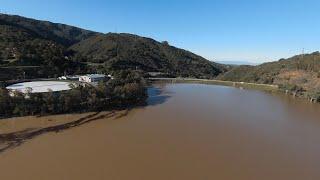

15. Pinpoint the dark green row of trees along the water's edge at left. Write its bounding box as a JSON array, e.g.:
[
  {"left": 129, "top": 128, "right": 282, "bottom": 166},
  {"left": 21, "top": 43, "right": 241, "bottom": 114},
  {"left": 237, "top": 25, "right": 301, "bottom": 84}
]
[{"left": 0, "top": 71, "right": 147, "bottom": 117}]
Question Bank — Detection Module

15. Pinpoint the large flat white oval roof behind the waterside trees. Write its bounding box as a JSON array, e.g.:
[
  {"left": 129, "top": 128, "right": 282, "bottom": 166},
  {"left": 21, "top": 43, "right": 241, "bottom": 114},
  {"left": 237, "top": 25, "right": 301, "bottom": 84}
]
[{"left": 7, "top": 81, "right": 71, "bottom": 93}]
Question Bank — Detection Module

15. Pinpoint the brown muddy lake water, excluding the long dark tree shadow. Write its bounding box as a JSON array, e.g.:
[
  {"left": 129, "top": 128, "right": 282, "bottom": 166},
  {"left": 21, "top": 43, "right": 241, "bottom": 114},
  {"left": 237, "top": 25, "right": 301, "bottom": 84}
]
[{"left": 0, "top": 84, "right": 320, "bottom": 180}]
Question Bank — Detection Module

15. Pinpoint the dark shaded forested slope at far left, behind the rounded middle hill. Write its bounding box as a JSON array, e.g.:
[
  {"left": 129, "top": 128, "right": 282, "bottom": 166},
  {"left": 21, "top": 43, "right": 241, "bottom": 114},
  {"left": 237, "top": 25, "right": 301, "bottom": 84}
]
[{"left": 0, "top": 14, "right": 96, "bottom": 80}]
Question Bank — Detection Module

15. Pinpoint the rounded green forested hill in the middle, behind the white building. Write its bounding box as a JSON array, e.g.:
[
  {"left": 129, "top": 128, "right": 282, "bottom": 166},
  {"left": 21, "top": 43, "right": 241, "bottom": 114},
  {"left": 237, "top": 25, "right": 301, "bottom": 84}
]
[{"left": 71, "top": 33, "right": 224, "bottom": 78}]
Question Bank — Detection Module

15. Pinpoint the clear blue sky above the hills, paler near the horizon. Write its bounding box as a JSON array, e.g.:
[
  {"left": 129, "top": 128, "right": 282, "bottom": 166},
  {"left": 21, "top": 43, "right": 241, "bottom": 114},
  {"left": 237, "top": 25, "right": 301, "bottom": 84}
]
[{"left": 0, "top": 0, "right": 320, "bottom": 63}]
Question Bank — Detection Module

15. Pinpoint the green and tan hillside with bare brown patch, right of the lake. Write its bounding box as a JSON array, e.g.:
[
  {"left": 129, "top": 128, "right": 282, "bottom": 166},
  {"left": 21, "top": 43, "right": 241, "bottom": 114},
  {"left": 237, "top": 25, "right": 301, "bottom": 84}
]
[{"left": 218, "top": 52, "right": 320, "bottom": 100}]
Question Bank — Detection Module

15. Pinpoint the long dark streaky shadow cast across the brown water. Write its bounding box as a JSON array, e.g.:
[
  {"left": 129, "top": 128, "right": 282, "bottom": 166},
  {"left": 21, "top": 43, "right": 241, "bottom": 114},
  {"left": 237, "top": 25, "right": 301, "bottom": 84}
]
[{"left": 0, "top": 112, "right": 119, "bottom": 153}]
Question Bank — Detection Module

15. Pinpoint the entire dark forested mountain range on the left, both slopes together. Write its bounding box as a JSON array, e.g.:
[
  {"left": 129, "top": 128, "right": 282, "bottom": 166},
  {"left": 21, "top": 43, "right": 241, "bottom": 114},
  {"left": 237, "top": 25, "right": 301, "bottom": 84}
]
[{"left": 0, "top": 14, "right": 226, "bottom": 80}]
